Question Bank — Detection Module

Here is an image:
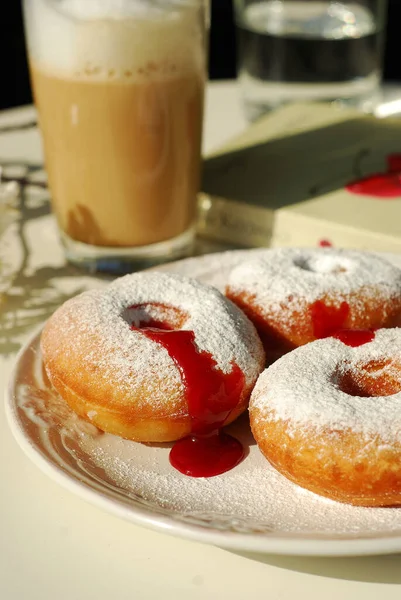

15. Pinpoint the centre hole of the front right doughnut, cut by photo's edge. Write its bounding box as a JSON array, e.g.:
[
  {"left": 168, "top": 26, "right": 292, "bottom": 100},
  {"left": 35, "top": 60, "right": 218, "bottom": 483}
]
[{"left": 336, "top": 359, "right": 401, "bottom": 398}]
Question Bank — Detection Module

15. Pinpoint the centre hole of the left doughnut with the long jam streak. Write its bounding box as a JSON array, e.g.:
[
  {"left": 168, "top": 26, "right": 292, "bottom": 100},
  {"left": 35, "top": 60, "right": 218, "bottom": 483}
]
[{"left": 123, "top": 302, "right": 189, "bottom": 331}]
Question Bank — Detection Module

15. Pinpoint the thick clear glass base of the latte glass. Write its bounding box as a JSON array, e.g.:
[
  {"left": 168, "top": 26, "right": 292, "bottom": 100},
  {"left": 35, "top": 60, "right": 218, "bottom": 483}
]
[{"left": 61, "top": 227, "right": 195, "bottom": 275}]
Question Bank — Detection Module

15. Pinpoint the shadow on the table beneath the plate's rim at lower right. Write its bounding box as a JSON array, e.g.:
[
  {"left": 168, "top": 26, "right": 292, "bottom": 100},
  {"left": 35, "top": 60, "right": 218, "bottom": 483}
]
[{"left": 227, "top": 551, "right": 401, "bottom": 585}]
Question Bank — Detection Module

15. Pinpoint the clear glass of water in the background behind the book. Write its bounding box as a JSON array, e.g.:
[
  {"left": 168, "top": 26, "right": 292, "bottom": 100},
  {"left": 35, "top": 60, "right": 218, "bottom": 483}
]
[{"left": 234, "top": 0, "right": 387, "bottom": 120}]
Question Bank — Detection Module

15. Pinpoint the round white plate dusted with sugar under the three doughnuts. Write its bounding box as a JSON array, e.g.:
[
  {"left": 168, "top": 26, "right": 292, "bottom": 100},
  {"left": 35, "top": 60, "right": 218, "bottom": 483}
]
[{"left": 6, "top": 250, "right": 401, "bottom": 556}]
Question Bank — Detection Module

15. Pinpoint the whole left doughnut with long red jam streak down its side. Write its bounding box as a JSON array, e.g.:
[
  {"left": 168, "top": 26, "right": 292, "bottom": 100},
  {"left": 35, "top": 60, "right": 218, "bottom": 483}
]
[{"left": 41, "top": 272, "right": 264, "bottom": 442}]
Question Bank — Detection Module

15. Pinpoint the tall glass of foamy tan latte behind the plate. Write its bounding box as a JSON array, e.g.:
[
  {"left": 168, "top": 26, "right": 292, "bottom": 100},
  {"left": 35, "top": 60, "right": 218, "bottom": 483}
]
[{"left": 24, "top": 0, "right": 207, "bottom": 272}]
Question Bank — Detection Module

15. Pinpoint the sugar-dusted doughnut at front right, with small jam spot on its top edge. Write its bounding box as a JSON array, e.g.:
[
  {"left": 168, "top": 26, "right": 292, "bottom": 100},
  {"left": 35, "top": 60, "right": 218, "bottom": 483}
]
[{"left": 249, "top": 328, "right": 401, "bottom": 506}]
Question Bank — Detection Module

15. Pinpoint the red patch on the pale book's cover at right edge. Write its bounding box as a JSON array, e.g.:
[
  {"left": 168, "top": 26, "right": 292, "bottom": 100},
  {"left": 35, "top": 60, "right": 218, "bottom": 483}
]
[{"left": 346, "top": 154, "right": 401, "bottom": 199}]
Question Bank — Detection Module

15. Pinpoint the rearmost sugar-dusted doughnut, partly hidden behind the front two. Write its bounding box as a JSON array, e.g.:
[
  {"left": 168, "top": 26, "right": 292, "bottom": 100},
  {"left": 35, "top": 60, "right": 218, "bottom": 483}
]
[{"left": 226, "top": 248, "right": 401, "bottom": 361}]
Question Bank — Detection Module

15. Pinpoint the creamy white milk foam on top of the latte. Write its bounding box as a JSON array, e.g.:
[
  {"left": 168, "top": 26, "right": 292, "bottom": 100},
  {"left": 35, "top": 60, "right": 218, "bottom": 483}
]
[{"left": 25, "top": 0, "right": 204, "bottom": 82}]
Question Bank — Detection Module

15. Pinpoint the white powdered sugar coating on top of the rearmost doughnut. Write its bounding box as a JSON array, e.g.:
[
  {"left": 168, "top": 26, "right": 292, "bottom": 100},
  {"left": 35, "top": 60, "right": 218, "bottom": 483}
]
[{"left": 228, "top": 248, "right": 401, "bottom": 311}]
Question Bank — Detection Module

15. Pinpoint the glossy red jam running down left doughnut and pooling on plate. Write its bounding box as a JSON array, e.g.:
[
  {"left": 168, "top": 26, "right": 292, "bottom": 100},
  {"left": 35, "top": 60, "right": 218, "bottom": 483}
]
[{"left": 132, "top": 314, "right": 245, "bottom": 477}]
